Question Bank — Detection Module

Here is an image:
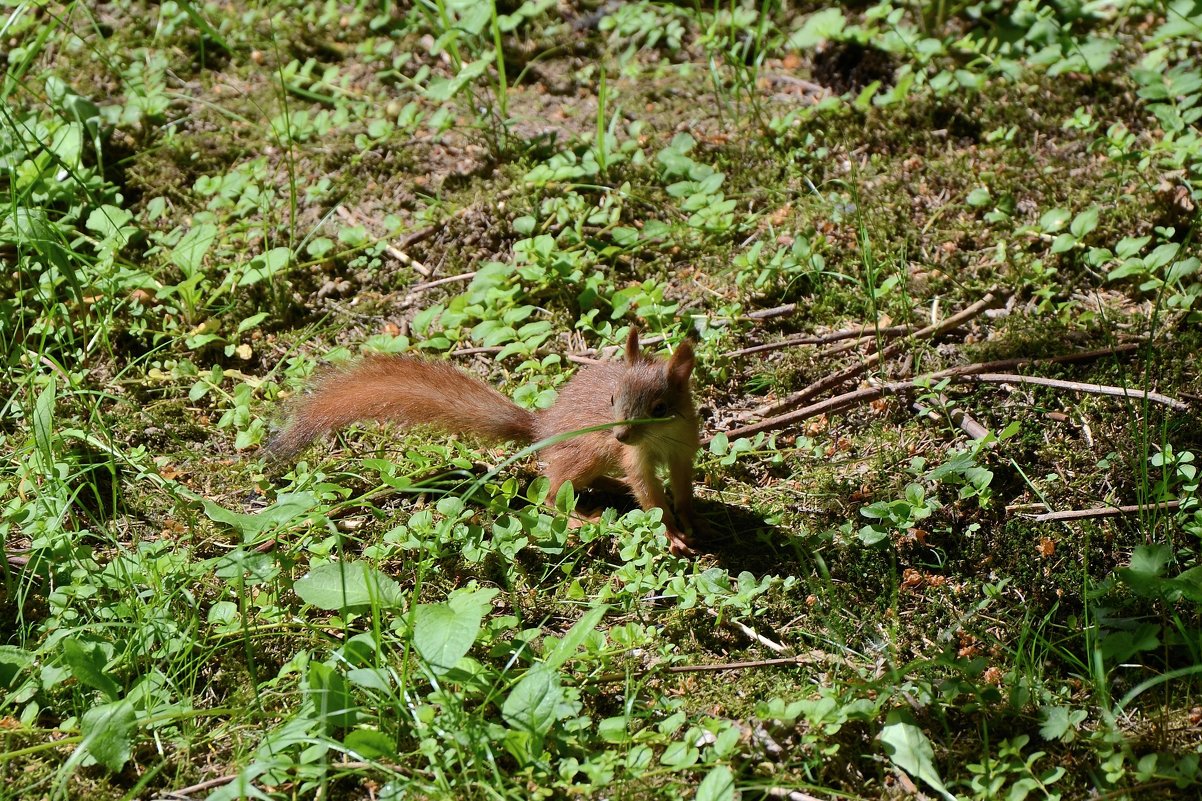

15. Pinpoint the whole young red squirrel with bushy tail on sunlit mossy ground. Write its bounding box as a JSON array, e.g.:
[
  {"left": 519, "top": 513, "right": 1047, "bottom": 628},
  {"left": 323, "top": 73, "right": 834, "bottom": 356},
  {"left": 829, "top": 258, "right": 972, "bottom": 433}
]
[{"left": 267, "top": 327, "right": 701, "bottom": 556}]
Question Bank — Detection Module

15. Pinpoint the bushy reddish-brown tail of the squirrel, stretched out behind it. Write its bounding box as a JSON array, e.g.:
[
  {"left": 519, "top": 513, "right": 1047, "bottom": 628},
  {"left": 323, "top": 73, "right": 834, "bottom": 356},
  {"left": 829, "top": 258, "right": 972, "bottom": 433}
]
[{"left": 267, "top": 356, "right": 536, "bottom": 458}]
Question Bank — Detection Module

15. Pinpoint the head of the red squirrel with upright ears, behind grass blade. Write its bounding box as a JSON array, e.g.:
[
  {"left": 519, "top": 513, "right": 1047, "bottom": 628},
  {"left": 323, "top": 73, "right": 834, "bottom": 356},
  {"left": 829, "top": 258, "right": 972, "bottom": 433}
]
[{"left": 609, "top": 326, "right": 694, "bottom": 445}]
